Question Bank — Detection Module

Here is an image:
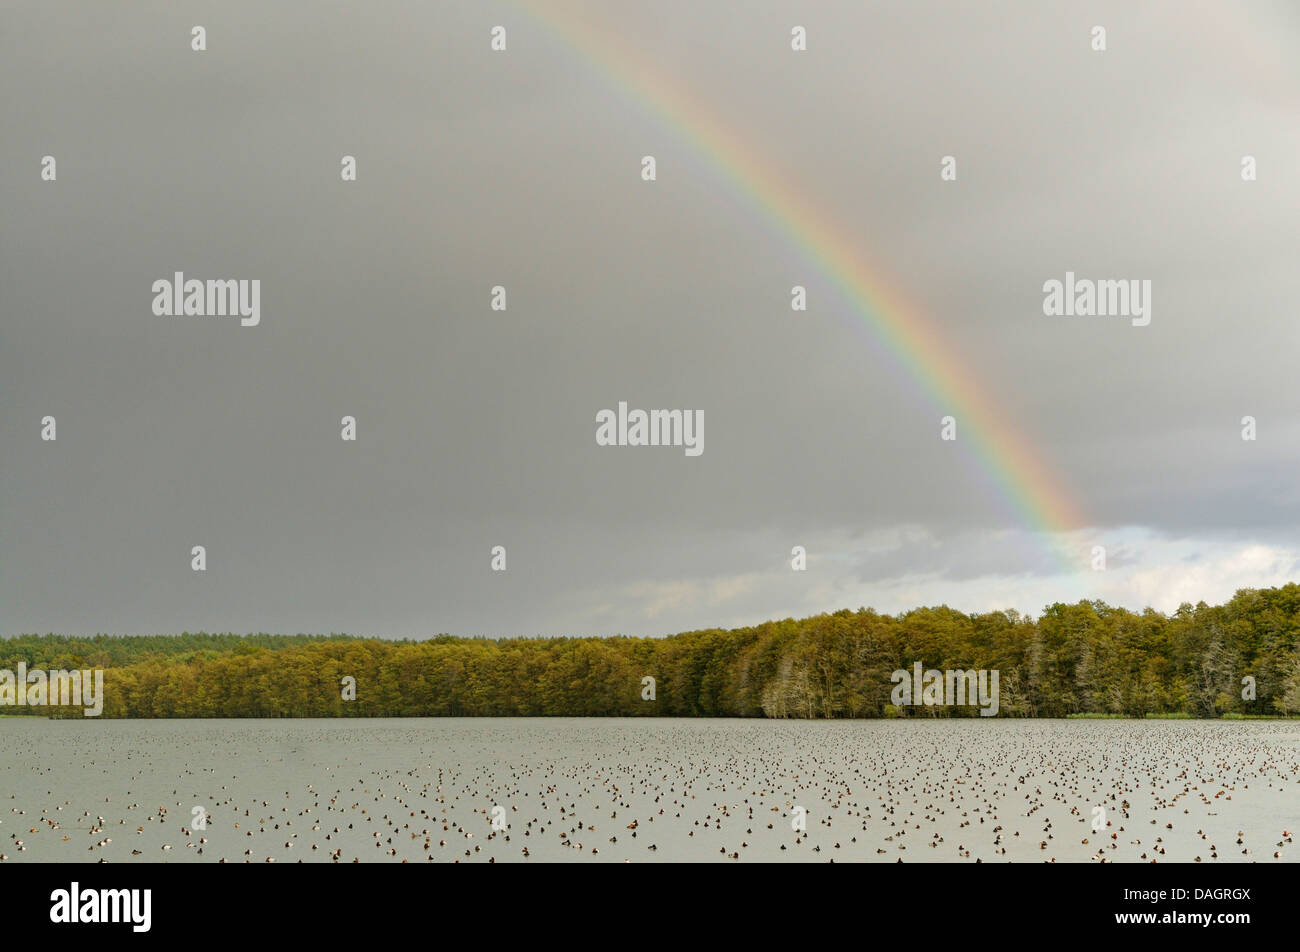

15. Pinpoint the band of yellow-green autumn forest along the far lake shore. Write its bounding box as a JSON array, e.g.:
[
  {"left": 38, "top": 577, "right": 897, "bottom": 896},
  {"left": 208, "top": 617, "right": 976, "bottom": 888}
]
[{"left": 0, "top": 584, "right": 1300, "bottom": 718}]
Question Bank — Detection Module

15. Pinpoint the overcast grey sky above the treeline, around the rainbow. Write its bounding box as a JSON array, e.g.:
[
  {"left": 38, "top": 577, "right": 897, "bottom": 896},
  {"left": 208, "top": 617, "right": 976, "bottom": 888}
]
[{"left": 0, "top": 0, "right": 1300, "bottom": 636}]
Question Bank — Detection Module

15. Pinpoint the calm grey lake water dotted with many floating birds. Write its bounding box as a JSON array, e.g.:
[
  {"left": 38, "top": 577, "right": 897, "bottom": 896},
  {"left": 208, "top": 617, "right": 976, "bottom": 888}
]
[{"left": 0, "top": 718, "right": 1300, "bottom": 864}]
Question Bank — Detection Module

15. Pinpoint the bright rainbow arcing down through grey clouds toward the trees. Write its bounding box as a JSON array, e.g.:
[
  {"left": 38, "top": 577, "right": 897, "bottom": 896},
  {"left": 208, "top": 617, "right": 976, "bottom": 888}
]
[{"left": 520, "top": 0, "right": 1086, "bottom": 551}]
